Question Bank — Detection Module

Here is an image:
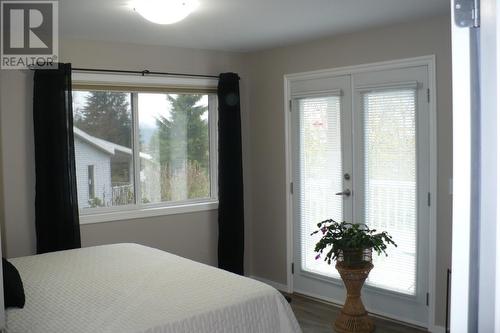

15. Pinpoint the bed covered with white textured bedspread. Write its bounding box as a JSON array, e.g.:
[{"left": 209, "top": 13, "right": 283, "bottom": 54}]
[{"left": 6, "top": 244, "right": 301, "bottom": 333}]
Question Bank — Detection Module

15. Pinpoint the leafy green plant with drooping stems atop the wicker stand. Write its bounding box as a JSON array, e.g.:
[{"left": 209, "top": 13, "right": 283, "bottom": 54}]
[{"left": 311, "top": 219, "right": 397, "bottom": 265}]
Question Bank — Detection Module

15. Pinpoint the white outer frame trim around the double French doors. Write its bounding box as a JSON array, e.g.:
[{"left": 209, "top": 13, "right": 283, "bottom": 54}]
[{"left": 284, "top": 55, "right": 437, "bottom": 329}]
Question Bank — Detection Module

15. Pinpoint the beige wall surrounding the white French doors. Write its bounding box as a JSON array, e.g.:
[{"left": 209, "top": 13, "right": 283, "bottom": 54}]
[{"left": 245, "top": 17, "right": 452, "bottom": 324}]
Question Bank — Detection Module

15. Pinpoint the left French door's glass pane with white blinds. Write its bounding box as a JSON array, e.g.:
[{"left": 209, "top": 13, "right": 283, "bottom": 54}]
[{"left": 298, "top": 96, "right": 343, "bottom": 277}]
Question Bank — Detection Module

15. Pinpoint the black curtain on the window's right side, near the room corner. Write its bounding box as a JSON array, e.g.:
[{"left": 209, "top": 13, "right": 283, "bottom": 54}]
[{"left": 217, "top": 73, "right": 244, "bottom": 275}]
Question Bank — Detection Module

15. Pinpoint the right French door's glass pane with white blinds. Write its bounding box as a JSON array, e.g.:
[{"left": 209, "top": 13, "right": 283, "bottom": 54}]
[{"left": 362, "top": 89, "right": 417, "bottom": 295}]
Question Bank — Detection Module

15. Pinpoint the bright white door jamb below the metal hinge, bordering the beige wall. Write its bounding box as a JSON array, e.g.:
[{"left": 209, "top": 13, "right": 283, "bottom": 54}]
[{"left": 450, "top": 1, "right": 478, "bottom": 333}]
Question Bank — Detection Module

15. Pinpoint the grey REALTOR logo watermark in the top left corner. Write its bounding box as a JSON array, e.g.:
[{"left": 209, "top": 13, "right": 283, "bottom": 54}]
[{"left": 0, "top": 0, "right": 59, "bottom": 69}]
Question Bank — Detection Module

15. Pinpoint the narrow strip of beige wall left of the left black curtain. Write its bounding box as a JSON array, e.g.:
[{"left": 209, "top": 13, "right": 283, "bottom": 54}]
[{"left": 0, "top": 70, "right": 35, "bottom": 257}]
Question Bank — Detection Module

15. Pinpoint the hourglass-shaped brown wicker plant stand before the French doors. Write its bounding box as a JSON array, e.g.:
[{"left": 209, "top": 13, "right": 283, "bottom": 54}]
[{"left": 334, "top": 253, "right": 375, "bottom": 333}]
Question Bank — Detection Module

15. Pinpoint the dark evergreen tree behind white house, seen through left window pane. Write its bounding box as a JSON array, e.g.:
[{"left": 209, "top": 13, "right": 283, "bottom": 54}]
[{"left": 75, "top": 91, "right": 132, "bottom": 147}]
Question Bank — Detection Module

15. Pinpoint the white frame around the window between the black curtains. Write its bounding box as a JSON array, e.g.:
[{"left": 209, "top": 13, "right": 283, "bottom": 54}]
[{"left": 72, "top": 72, "right": 219, "bottom": 224}]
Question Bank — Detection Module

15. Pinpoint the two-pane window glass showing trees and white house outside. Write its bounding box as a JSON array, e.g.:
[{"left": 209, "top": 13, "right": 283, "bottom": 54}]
[{"left": 73, "top": 79, "right": 217, "bottom": 223}]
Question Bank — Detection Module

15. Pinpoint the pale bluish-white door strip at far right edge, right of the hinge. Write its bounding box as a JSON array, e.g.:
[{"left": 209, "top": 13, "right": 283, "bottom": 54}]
[{"left": 478, "top": 0, "right": 500, "bottom": 332}]
